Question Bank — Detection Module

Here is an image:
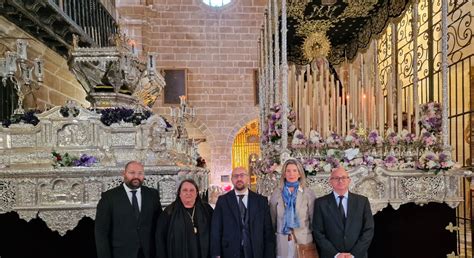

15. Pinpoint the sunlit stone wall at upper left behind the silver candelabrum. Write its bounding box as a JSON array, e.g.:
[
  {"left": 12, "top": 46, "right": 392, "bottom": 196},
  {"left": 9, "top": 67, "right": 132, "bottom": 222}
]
[{"left": 0, "top": 17, "right": 89, "bottom": 110}]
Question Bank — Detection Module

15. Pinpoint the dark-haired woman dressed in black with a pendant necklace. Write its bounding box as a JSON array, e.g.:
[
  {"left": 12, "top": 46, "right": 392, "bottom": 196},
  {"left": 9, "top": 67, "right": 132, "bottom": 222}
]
[{"left": 156, "top": 179, "right": 213, "bottom": 258}]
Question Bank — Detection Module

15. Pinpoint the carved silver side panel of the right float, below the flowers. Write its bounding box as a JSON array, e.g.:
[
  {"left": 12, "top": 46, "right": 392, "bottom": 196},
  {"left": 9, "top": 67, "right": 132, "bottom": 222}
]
[{"left": 268, "top": 167, "right": 471, "bottom": 214}]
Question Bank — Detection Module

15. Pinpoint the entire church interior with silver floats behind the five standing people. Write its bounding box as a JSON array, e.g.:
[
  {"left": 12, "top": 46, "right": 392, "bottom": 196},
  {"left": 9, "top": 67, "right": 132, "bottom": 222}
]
[{"left": 0, "top": 0, "right": 474, "bottom": 258}]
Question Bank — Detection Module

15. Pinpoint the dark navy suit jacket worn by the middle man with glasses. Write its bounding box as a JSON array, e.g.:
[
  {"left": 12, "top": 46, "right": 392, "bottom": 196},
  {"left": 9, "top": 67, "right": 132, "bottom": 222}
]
[{"left": 211, "top": 190, "right": 275, "bottom": 258}]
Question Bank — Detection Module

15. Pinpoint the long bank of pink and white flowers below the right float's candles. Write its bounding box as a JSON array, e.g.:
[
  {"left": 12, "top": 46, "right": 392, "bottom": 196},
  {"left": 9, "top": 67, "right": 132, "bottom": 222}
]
[{"left": 258, "top": 102, "right": 455, "bottom": 175}]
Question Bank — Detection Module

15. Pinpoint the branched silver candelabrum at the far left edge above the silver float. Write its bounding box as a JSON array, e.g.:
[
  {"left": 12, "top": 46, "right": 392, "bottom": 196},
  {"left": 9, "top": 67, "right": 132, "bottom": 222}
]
[{"left": 0, "top": 39, "right": 44, "bottom": 114}]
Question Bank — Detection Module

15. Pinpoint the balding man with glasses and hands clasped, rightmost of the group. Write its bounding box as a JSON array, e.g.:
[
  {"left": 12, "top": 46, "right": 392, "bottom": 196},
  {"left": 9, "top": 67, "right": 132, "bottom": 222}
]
[{"left": 313, "top": 167, "right": 374, "bottom": 258}]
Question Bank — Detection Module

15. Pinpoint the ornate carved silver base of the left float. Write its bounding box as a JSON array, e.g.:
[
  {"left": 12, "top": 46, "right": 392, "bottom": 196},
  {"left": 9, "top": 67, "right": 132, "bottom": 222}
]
[{"left": 0, "top": 106, "right": 209, "bottom": 234}]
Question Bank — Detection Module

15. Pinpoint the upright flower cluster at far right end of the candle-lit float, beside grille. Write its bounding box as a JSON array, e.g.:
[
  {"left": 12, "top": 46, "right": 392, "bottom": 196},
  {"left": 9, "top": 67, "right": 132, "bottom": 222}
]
[{"left": 418, "top": 102, "right": 442, "bottom": 135}]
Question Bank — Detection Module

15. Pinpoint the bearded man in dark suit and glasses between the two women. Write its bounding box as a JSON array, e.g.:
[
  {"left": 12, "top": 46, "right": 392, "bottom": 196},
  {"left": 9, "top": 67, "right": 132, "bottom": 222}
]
[{"left": 211, "top": 167, "right": 275, "bottom": 258}]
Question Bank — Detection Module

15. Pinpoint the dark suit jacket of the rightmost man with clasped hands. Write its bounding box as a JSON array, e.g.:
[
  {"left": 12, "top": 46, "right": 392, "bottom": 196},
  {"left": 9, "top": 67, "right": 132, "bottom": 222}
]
[{"left": 313, "top": 192, "right": 374, "bottom": 258}]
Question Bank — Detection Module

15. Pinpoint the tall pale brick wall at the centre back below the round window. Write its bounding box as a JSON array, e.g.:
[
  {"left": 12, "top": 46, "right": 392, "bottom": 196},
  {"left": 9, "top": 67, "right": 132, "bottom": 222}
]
[{"left": 117, "top": 0, "right": 266, "bottom": 183}]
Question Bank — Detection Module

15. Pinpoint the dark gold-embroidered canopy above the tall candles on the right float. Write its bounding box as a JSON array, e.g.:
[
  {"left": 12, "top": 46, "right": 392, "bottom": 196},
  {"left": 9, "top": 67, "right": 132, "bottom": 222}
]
[{"left": 288, "top": 0, "right": 410, "bottom": 65}]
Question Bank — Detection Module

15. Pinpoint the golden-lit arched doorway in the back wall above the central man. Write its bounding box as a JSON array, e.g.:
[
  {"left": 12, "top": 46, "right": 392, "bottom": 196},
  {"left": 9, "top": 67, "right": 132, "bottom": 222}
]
[{"left": 232, "top": 119, "right": 260, "bottom": 186}]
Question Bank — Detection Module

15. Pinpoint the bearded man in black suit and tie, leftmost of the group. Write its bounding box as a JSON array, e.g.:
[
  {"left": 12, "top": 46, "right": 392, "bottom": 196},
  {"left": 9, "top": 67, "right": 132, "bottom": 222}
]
[{"left": 95, "top": 161, "right": 161, "bottom": 258}]
